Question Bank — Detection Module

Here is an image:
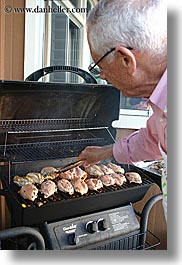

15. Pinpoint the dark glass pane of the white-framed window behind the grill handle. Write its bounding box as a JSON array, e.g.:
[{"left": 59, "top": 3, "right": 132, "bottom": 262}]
[{"left": 50, "top": 2, "right": 83, "bottom": 83}]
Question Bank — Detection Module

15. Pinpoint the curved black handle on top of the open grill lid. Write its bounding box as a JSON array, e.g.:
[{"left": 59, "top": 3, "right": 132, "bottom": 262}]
[{"left": 25, "top": 65, "right": 97, "bottom": 84}]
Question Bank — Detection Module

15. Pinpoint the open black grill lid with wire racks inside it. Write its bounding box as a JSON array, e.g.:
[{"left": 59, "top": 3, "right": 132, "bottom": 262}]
[{"left": 0, "top": 81, "right": 120, "bottom": 161}]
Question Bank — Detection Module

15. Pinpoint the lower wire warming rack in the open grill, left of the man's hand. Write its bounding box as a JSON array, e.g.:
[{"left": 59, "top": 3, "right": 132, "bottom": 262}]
[{"left": 0, "top": 138, "right": 106, "bottom": 162}]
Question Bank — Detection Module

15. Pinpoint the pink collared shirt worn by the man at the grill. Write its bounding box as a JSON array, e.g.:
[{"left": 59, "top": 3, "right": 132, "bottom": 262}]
[{"left": 113, "top": 70, "right": 167, "bottom": 164}]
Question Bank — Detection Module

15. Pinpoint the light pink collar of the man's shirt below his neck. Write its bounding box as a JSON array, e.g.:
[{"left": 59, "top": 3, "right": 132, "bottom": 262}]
[{"left": 149, "top": 69, "right": 167, "bottom": 111}]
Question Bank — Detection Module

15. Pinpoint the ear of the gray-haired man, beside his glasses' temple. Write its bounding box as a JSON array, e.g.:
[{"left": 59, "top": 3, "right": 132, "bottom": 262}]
[{"left": 115, "top": 46, "right": 136, "bottom": 75}]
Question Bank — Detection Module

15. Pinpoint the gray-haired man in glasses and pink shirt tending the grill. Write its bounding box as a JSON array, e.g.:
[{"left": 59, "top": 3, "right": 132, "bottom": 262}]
[{"left": 78, "top": 0, "right": 167, "bottom": 219}]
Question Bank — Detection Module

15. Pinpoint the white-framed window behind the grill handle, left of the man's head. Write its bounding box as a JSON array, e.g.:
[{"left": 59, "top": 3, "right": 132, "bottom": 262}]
[{"left": 25, "top": 0, "right": 95, "bottom": 83}]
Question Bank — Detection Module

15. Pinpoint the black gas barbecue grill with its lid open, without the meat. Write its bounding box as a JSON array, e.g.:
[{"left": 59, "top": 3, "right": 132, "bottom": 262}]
[{"left": 0, "top": 66, "right": 160, "bottom": 249}]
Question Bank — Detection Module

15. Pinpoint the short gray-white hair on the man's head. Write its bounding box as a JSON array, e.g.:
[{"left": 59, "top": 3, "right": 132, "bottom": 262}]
[{"left": 87, "top": 0, "right": 167, "bottom": 55}]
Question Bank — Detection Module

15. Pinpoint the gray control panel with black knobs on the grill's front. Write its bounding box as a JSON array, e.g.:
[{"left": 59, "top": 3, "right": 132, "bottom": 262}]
[{"left": 44, "top": 205, "right": 140, "bottom": 250}]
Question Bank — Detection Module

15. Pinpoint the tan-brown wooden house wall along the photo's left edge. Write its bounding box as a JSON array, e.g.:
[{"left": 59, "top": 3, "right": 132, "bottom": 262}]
[{"left": 0, "top": 0, "right": 25, "bottom": 229}]
